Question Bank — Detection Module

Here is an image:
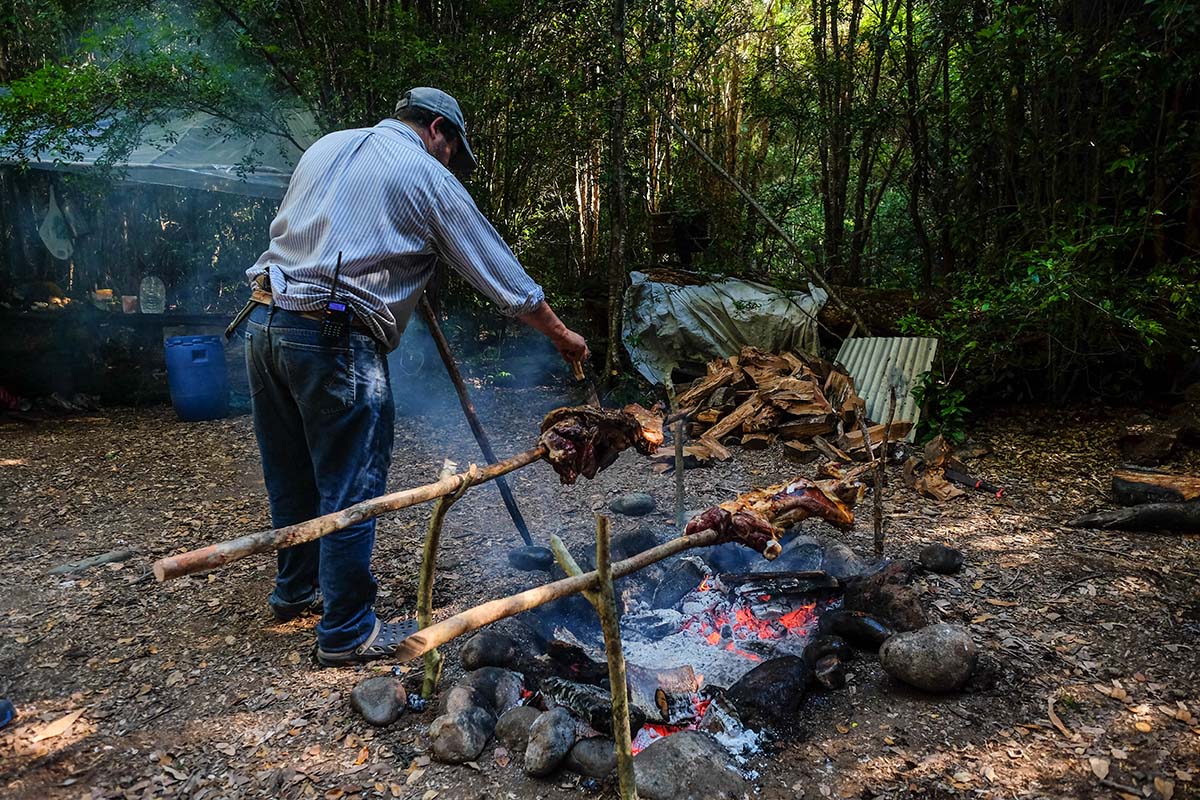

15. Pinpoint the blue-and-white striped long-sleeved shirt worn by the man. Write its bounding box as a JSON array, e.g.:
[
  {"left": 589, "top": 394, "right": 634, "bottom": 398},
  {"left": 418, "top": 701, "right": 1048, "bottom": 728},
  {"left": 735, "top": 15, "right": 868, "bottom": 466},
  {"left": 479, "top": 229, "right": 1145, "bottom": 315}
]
[{"left": 246, "top": 119, "right": 545, "bottom": 350}]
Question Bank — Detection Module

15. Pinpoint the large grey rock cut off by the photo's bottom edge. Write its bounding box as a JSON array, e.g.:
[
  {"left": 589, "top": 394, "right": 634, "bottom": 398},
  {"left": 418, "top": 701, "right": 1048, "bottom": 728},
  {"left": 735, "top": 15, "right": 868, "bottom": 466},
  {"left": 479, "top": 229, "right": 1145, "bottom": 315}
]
[{"left": 634, "top": 730, "right": 751, "bottom": 800}]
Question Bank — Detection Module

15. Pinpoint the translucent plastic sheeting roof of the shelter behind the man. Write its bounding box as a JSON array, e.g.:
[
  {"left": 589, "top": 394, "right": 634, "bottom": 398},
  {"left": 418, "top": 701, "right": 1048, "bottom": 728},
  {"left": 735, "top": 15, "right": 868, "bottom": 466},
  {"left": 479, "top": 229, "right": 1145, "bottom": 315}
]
[{"left": 0, "top": 105, "right": 319, "bottom": 198}]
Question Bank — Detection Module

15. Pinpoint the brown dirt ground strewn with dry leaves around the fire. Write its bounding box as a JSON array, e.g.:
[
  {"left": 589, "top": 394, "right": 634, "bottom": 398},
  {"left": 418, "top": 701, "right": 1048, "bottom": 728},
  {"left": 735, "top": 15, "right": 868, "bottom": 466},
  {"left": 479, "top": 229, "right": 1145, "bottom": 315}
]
[{"left": 0, "top": 389, "right": 1200, "bottom": 800}]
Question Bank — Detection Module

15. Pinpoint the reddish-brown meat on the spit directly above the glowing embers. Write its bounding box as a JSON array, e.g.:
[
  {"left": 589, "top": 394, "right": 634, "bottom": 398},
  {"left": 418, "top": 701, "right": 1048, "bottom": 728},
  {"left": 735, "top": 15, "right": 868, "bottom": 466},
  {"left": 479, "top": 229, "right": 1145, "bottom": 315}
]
[{"left": 684, "top": 465, "right": 864, "bottom": 560}]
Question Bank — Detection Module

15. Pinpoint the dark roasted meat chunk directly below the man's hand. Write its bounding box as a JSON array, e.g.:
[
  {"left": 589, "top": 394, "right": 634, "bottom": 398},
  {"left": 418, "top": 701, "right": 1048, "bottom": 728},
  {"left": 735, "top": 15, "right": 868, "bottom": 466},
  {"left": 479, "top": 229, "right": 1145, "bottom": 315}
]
[{"left": 541, "top": 403, "right": 662, "bottom": 485}]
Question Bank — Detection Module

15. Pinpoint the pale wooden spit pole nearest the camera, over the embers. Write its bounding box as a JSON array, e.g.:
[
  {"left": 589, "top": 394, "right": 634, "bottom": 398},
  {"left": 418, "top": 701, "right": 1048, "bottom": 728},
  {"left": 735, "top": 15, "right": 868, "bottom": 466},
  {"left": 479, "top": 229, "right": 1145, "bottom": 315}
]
[{"left": 394, "top": 530, "right": 721, "bottom": 662}]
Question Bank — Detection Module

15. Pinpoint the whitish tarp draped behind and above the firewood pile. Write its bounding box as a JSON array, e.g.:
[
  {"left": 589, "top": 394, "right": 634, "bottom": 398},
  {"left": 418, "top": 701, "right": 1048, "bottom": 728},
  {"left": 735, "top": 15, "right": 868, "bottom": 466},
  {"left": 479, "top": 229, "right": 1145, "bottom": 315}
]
[{"left": 622, "top": 272, "right": 828, "bottom": 384}]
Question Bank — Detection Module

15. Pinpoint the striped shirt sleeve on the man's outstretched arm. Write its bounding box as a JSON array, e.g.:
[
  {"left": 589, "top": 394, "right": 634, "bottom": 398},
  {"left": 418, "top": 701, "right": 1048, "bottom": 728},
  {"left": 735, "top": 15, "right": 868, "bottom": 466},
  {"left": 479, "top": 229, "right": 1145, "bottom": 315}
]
[{"left": 430, "top": 175, "right": 546, "bottom": 317}]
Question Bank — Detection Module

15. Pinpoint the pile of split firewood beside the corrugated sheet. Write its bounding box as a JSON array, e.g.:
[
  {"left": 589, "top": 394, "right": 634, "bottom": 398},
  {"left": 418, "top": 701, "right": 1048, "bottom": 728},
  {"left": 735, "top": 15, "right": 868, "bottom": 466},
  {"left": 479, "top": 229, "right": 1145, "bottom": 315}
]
[{"left": 654, "top": 347, "right": 911, "bottom": 473}]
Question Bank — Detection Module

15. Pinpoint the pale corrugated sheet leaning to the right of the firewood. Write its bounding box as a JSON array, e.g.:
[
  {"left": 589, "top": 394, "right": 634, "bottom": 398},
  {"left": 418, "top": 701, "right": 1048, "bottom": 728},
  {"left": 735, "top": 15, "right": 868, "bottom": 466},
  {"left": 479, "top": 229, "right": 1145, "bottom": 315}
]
[{"left": 838, "top": 337, "right": 937, "bottom": 441}]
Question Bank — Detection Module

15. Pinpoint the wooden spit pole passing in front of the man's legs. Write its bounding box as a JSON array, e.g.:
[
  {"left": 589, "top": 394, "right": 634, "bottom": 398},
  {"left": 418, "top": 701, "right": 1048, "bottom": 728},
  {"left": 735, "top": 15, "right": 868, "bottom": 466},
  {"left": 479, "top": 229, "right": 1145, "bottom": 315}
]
[{"left": 154, "top": 445, "right": 547, "bottom": 583}]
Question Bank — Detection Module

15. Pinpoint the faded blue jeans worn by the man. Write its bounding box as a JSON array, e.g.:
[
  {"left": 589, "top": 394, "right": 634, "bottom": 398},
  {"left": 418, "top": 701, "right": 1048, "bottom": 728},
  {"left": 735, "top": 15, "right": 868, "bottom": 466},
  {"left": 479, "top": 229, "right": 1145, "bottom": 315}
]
[{"left": 246, "top": 306, "right": 395, "bottom": 652}]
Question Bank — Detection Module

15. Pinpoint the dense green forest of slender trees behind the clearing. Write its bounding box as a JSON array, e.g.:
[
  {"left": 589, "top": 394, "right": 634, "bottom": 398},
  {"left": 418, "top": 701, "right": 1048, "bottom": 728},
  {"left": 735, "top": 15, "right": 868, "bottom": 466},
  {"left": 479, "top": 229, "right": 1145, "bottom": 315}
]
[{"left": 0, "top": 0, "right": 1200, "bottom": 414}]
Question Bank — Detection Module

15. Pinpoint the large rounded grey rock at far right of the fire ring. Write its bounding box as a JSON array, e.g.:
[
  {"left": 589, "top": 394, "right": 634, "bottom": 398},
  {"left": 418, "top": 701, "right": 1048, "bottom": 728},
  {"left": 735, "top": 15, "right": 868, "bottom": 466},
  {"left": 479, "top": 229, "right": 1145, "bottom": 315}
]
[{"left": 880, "top": 625, "right": 979, "bottom": 692}]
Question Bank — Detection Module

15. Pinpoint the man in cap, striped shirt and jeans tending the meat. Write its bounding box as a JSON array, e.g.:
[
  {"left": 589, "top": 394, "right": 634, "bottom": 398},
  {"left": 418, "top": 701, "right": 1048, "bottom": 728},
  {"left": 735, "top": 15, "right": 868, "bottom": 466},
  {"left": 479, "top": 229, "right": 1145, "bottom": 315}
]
[{"left": 246, "top": 88, "right": 588, "bottom": 666}]
